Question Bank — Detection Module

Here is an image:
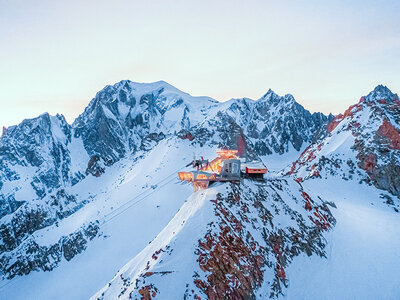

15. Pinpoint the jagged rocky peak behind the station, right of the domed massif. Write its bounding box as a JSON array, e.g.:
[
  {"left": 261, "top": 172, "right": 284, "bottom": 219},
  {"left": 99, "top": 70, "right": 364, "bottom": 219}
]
[{"left": 220, "top": 90, "right": 332, "bottom": 155}]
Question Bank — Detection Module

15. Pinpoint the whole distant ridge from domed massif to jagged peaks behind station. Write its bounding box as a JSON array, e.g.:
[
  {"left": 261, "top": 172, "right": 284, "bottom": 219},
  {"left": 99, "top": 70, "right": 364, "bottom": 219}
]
[{"left": 73, "top": 81, "right": 329, "bottom": 161}]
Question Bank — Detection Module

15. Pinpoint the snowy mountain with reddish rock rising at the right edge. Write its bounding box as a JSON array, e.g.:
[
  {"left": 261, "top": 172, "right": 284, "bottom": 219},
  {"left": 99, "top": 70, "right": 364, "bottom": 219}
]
[{"left": 288, "top": 85, "right": 400, "bottom": 210}]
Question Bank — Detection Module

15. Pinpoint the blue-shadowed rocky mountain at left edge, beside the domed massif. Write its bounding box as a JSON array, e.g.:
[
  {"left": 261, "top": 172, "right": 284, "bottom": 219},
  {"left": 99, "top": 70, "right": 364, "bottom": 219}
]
[{"left": 0, "top": 113, "right": 82, "bottom": 206}]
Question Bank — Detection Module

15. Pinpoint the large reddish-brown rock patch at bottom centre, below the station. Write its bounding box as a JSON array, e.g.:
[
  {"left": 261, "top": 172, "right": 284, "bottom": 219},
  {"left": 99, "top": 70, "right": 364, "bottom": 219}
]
[{"left": 194, "top": 223, "right": 265, "bottom": 299}]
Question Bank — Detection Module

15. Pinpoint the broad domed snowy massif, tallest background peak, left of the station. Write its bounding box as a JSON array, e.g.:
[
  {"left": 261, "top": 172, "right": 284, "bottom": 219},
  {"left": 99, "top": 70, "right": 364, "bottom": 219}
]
[{"left": 72, "top": 81, "right": 217, "bottom": 162}]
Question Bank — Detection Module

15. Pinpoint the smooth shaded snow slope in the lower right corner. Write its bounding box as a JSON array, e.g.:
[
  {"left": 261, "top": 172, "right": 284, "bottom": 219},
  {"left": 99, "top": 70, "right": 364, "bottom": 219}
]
[{"left": 284, "top": 179, "right": 400, "bottom": 299}]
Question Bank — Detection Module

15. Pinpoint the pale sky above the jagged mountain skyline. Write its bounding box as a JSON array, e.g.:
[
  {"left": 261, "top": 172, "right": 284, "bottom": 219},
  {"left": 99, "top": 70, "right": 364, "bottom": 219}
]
[{"left": 0, "top": 0, "right": 400, "bottom": 126}]
